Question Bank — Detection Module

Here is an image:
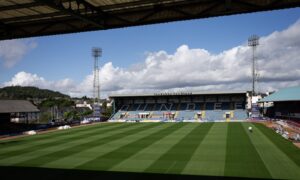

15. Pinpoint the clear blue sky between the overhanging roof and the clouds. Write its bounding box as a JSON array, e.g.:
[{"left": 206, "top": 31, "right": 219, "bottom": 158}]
[{"left": 0, "top": 8, "right": 300, "bottom": 97}]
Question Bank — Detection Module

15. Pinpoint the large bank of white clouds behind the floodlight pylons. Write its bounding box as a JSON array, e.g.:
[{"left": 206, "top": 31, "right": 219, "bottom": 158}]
[{"left": 2, "top": 21, "right": 300, "bottom": 96}]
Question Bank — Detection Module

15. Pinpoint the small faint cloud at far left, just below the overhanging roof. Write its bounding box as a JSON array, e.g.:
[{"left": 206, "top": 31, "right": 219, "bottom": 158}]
[{"left": 0, "top": 40, "right": 37, "bottom": 68}]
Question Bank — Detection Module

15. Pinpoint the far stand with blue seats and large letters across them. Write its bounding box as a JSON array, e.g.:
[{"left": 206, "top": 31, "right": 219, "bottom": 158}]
[{"left": 109, "top": 91, "right": 249, "bottom": 122}]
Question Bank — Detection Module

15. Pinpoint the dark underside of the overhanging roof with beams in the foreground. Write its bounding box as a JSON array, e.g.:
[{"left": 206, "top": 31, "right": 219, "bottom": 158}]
[{"left": 0, "top": 0, "right": 300, "bottom": 40}]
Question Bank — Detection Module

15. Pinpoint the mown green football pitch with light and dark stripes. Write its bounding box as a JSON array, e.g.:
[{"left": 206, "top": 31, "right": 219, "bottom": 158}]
[{"left": 0, "top": 122, "right": 300, "bottom": 179}]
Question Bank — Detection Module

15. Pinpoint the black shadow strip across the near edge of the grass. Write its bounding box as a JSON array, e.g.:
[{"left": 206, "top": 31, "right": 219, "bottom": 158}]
[{"left": 0, "top": 166, "right": 266, "bottom": 180}]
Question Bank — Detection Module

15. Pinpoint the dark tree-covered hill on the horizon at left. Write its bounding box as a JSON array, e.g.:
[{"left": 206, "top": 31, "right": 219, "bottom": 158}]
[{"left": 0, "top": 86, "right": 70, "bottom": 99}]
